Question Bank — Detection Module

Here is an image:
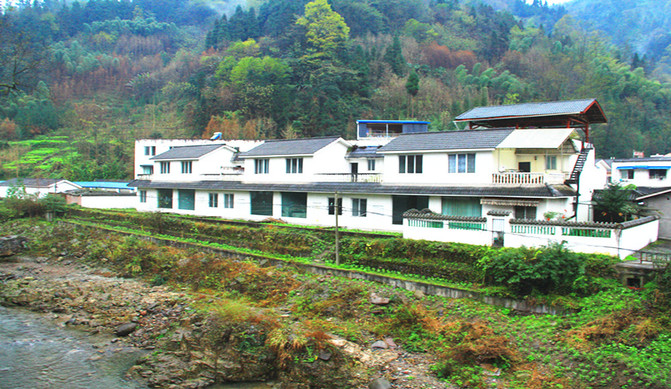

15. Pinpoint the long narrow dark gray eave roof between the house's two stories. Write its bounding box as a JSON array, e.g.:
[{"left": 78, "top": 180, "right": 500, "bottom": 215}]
[{"left": 128, "top": 180, "right": 575, "bottom": 198}]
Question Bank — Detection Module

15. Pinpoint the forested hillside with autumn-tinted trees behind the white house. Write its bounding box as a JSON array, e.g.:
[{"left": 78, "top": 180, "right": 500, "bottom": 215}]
[{"left": 0, "top": 0, "right": 671, "bottom": 180}]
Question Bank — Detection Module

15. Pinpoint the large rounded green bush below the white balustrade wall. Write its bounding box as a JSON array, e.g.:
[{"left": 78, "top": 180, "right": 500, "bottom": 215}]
[{"left": 478, "top": 244, "right": 585, "bottom": 295}]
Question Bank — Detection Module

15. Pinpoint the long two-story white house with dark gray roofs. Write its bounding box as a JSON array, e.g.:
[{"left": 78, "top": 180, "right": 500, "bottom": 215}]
[{"left": 131, "top": 101, "right": 660, "bottom": 255}]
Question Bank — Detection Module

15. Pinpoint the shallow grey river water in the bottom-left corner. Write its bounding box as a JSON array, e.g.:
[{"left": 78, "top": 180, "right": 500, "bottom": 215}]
[{"left": 0, "top": 307, "right": 146, "bottom": 389}]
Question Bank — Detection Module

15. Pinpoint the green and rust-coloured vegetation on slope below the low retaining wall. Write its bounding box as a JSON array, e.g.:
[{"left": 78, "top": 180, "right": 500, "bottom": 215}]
[{"left": 2, "top": 206, "right": 671, "bottom": 388}]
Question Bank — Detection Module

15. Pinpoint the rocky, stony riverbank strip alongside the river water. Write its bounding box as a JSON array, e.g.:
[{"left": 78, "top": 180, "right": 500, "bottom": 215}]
[{"left": 0, "top": 232, "right": 446, "bottom": 388}]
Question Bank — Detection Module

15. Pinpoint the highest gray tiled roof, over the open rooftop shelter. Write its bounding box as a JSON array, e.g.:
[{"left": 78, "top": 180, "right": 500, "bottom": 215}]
[{"left": 455, "top": 99, "right": 596, "bottom": 121}]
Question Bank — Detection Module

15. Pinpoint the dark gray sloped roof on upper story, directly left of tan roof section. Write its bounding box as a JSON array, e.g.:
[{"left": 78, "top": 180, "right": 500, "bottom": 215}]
[{"left": 379, "top": 128, "right": 513, "bottom": 153}]
